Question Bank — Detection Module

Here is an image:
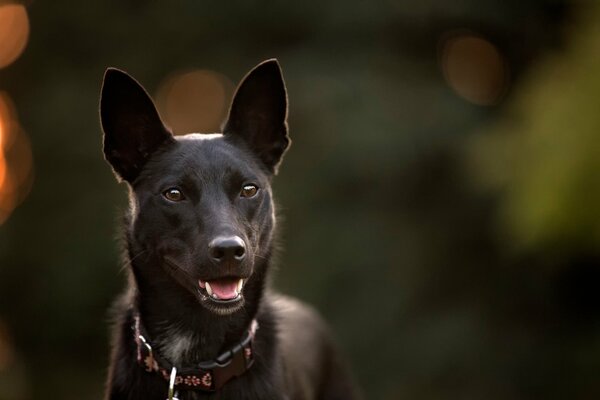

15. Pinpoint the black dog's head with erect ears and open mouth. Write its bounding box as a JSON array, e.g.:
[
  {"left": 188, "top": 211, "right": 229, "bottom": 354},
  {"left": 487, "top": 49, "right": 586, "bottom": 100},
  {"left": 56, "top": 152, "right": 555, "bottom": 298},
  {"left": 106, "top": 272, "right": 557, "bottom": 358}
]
[{"left": 100, "top": 60, "right": 290, "bottom": 314}]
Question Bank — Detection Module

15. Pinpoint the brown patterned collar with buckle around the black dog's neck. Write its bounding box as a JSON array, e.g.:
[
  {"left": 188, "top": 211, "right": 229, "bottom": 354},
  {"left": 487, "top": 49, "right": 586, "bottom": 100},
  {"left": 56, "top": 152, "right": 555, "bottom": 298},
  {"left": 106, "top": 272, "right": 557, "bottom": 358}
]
[{"left": 133, "top": 313, "right": 258, "bottom": 392}]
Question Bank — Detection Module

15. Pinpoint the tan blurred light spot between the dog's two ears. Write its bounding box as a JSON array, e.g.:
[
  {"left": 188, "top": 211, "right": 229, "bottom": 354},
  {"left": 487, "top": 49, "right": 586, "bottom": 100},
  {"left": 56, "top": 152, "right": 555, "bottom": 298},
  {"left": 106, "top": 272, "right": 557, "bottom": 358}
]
[{"left": 156, "top": 70, "right": 233, "bottom": 134}]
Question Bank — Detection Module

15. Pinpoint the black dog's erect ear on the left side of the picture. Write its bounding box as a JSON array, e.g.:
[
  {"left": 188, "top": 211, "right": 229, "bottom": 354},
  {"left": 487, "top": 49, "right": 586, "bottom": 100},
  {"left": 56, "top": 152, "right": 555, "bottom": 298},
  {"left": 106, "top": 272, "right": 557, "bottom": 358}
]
[{"left": 100, "top": 68, "right": 175, "bottom": 183}]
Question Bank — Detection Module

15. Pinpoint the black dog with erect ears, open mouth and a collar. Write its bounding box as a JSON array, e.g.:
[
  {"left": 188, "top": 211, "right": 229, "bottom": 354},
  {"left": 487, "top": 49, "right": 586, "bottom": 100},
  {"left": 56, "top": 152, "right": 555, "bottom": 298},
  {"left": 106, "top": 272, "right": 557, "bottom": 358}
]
[{"left": 100, "top": 60, "right": 355, "bottom": 400}]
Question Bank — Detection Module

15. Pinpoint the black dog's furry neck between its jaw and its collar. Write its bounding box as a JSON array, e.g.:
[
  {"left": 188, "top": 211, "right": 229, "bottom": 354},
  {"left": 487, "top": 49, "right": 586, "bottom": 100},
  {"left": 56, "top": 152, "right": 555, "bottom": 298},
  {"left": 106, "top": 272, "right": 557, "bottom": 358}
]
[{"left": 130, "top": 253, "right": 263, "bottom": 365}]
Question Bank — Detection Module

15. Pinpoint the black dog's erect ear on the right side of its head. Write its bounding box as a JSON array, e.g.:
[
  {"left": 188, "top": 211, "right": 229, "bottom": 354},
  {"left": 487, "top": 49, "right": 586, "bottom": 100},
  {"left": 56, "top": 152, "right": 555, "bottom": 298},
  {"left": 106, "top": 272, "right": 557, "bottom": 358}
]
[{"left": 223, "top": 59, "right": 290, "bottom": 174}]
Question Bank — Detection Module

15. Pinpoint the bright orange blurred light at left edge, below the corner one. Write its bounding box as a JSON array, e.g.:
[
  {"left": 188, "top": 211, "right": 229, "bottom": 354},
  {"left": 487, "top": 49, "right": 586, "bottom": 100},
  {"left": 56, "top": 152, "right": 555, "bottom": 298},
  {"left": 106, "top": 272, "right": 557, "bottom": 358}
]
[{"left": 0, "top": 92, "right": 33, "bottom": 224}]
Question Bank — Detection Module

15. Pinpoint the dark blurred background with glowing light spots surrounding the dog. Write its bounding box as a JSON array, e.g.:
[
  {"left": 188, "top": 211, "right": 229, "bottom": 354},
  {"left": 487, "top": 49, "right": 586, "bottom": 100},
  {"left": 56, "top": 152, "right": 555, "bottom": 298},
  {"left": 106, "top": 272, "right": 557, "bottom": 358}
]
[{"left": 0, "top": 0, "right": 600, "bottom": 400}]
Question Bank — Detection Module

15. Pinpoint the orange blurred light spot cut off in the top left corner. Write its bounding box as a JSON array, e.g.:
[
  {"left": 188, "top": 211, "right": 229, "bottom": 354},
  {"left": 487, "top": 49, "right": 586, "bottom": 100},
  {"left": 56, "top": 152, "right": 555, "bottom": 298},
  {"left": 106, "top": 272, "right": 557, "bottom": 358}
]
[{"left": 0, "top": 4, "right": 29, "bottom": 68}]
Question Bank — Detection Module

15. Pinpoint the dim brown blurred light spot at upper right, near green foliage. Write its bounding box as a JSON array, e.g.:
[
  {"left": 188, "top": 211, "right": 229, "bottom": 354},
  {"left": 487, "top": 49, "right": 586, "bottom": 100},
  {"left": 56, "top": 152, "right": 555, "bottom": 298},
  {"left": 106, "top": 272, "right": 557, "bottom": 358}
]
[{"left": 440, "top": 31, "right": 509, "bottom": 105}]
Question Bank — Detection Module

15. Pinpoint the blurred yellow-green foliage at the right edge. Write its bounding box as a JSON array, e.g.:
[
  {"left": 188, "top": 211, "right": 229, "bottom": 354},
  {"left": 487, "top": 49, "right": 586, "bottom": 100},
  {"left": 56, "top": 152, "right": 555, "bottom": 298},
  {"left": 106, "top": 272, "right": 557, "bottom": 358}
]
[{"left": 471, "top": 7, "right": 600, "bottom": 248}]
